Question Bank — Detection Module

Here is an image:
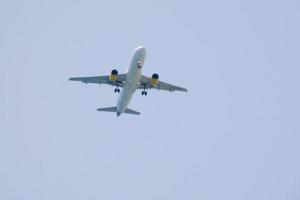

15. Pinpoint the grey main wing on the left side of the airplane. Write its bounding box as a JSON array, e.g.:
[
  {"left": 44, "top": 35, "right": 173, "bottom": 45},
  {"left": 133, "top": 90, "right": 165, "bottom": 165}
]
[{"left": 69, "top": 74, "right": 126, "bottom": 87}]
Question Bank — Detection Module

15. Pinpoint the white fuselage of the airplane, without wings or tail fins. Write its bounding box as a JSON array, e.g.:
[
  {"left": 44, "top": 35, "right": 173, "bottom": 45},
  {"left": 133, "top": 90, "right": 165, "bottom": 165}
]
[{"left": 117, "top": 47, "right": 146, "bottom": 116}]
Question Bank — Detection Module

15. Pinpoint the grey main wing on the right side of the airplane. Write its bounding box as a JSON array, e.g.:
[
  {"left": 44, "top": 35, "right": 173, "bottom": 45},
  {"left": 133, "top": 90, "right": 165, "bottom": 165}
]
[{"left": 138, "top": 75, "right": 187, "bottom": 92}]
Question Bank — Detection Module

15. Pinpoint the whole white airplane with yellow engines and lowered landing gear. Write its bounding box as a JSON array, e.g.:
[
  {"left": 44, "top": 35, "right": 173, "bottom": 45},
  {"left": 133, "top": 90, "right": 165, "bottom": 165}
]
[{"left": 69, "top": 46, "right": 187, "bottom": 117}]
